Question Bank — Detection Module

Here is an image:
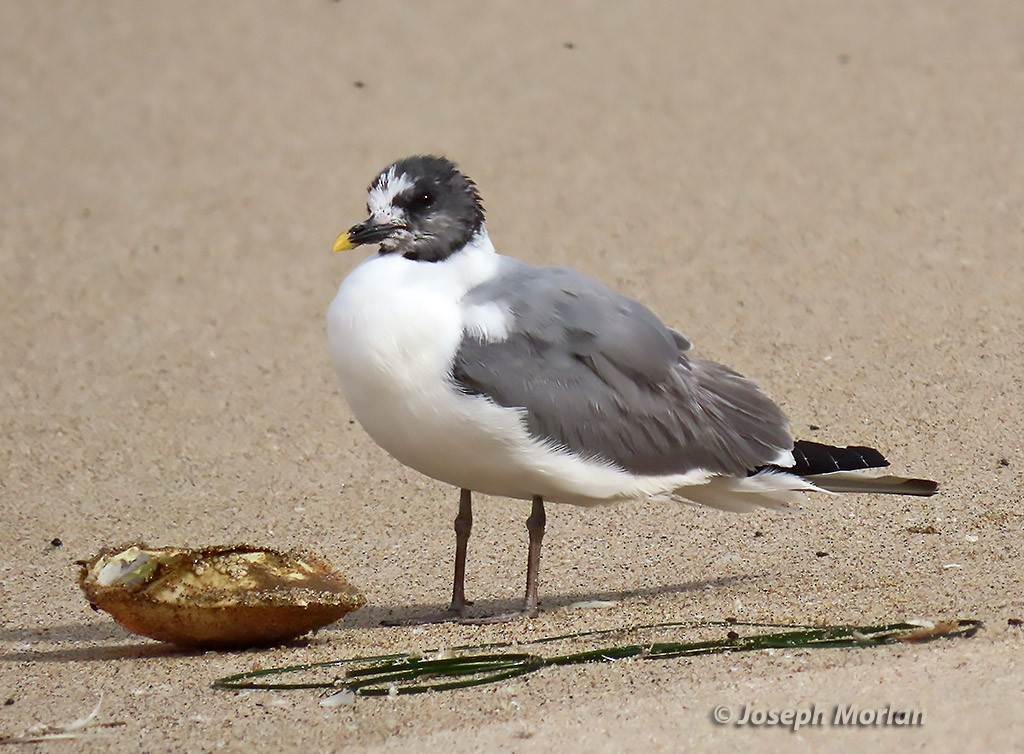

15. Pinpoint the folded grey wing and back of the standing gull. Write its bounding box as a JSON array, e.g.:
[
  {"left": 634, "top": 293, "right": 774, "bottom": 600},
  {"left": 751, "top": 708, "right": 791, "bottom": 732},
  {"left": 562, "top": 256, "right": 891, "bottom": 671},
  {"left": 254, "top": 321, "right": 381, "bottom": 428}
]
[{"left": 452, "top": 258, "right": 793, "bottom": 475}]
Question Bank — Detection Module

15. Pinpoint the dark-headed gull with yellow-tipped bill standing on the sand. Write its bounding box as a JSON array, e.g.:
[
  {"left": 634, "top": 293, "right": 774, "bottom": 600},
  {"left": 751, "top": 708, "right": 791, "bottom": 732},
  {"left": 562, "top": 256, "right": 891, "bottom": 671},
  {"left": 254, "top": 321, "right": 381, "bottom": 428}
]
[{"left": 327, "top": 156, "right": 938, "bottom": 620}]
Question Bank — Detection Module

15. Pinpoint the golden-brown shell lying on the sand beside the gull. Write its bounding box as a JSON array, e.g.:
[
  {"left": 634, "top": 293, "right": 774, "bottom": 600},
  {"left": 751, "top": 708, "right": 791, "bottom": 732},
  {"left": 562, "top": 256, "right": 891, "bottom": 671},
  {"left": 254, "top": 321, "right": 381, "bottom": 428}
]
[{"left": 78, "top": 544, "right": 367, "bottom": 648}]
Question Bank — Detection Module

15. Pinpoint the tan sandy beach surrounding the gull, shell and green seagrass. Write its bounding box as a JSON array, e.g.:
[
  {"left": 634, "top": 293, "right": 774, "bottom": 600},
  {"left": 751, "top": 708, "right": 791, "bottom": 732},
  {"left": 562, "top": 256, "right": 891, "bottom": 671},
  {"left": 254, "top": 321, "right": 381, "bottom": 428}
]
[{"left": 0, "top": 0, "right": 1024, "bottom": 754}]
